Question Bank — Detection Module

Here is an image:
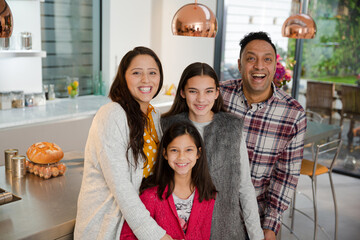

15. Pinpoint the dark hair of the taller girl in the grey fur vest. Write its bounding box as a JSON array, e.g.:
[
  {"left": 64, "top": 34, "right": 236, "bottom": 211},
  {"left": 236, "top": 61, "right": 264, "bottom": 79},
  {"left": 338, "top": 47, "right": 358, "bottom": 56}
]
[{"left": 162, "top": 62, "right": 226, "bottom": 117}]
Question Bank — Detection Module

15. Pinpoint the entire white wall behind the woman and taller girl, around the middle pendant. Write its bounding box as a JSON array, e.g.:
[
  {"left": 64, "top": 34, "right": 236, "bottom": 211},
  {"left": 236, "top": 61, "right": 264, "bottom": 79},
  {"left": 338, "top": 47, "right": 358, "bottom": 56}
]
[{"left": 103, "top": 0, "right": 216, "bottom": 89}]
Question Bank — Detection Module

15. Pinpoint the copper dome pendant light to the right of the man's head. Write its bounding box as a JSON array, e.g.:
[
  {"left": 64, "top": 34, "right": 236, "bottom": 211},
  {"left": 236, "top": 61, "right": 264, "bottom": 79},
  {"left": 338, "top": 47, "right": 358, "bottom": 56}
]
[{"left": 281, "top": 0, "right": 316, "bottom": 39}]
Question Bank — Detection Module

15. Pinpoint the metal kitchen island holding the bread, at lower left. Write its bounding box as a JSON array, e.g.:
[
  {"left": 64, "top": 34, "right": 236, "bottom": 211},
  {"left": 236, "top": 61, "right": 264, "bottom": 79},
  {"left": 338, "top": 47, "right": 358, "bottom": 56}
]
[{"left": 0, "top": 154, "right": 84, "bottom": 240}]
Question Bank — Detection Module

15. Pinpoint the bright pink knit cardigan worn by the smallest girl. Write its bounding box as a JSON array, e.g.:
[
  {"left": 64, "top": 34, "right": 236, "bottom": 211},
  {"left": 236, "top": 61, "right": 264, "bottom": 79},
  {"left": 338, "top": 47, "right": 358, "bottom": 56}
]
[{"left": 120, "top": 187, "right": 215, "bottom": 240}]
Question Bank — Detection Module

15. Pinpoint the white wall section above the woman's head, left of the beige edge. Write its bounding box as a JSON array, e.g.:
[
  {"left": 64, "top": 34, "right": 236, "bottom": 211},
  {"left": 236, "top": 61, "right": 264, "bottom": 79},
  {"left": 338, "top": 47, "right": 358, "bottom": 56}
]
[{"left": 102, "top": 0, "right": 152, "bottom": 90}]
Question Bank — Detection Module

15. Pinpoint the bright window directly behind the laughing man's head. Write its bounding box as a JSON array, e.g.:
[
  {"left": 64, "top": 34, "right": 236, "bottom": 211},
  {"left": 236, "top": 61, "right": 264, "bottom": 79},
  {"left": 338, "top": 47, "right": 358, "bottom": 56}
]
[{"left": 215, "top": 0, "right": 292, "bottom": 81}]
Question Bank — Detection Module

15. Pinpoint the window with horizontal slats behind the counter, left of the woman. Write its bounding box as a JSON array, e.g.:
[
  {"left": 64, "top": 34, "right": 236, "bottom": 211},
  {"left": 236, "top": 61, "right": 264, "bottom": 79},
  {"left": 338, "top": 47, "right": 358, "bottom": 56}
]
[{"left": 41, "top": 0, "right": 101, "bottom": 98}]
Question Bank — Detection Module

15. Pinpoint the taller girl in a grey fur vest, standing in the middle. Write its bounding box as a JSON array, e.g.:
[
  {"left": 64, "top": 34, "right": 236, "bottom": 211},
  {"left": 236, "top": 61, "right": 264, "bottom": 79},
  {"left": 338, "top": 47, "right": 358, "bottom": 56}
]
[{"left": 161, "top": 62, "right": 264, "bottom": 240}]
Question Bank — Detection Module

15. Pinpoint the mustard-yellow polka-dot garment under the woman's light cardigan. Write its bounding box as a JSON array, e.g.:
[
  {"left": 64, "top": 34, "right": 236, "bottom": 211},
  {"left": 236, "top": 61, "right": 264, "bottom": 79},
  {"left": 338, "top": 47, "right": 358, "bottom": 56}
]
[{"left": 143, "top": 104, "right": 159, "bottom": 178}]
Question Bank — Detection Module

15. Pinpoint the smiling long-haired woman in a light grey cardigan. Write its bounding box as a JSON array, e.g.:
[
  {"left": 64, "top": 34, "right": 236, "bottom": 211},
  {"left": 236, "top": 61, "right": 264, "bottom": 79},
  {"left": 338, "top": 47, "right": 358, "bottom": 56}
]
[{"left": 74, "top": 47, "right": 171, "bottom": 239}]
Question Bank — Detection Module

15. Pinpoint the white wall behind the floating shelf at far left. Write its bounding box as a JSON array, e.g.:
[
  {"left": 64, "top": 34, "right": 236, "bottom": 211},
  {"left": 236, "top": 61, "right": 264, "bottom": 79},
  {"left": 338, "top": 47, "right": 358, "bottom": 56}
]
[{"left": 0, "top": 0, "right": 42, "bottom": 93}]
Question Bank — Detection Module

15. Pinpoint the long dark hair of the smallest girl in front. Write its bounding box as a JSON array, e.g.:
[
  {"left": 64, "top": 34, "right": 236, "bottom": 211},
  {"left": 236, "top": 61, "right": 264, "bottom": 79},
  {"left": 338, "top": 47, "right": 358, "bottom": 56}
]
[{"left": 140, "top": 121, "right": 216, "bottom": 202}]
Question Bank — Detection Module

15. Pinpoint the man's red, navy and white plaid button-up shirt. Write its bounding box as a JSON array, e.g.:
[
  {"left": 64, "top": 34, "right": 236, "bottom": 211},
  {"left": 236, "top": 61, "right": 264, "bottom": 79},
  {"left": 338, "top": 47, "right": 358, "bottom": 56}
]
[{"left": 220, "top": 80, "right": 306, "bottom": 233}]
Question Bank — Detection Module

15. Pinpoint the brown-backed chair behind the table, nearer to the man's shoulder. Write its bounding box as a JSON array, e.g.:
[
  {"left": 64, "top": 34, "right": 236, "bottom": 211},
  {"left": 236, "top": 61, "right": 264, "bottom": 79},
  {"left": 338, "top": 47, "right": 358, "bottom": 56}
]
[{"left": 306, "top": 81, "right": 336, "bottom": 124}]
